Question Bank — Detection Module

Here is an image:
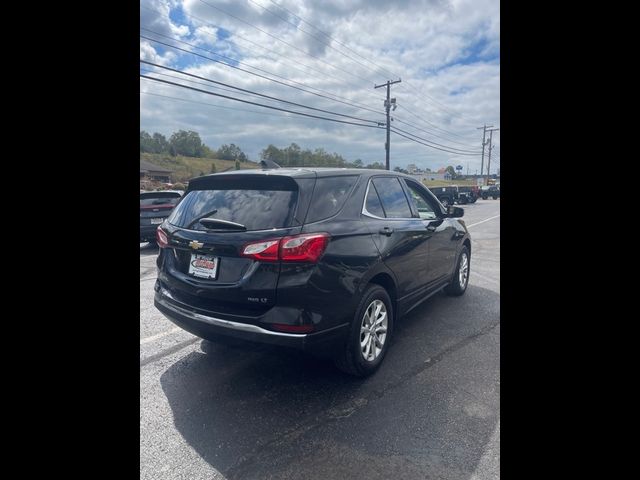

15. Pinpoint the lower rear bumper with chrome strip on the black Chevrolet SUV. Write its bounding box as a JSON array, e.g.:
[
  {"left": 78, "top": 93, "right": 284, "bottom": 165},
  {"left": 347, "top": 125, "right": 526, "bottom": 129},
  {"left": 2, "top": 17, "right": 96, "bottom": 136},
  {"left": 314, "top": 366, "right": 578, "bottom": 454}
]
[{"left": 154, "top": 287, "right": 349, "bottom": 354}]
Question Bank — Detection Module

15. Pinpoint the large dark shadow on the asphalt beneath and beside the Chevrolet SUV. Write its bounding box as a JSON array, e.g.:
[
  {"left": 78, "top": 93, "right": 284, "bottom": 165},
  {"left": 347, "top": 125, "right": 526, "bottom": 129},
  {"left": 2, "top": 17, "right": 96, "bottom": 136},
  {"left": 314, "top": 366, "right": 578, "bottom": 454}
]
[{"left": 156, "top": 285, "right": 500, "bottom": 479}]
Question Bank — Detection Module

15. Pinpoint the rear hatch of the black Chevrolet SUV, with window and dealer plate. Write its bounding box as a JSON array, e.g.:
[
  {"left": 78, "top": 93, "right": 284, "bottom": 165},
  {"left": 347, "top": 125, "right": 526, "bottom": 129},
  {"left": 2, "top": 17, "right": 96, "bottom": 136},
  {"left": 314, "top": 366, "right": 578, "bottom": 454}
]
[{"left": 159, "top": 174, "right": 315, "bottom": 321}]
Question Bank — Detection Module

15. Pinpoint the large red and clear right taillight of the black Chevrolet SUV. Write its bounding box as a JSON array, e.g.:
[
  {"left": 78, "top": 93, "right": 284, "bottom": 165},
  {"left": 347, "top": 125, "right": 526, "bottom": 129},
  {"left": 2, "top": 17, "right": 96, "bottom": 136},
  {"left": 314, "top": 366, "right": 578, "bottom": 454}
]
[{"left": 240, "top": 233, "right": 329, "bottom": 263}]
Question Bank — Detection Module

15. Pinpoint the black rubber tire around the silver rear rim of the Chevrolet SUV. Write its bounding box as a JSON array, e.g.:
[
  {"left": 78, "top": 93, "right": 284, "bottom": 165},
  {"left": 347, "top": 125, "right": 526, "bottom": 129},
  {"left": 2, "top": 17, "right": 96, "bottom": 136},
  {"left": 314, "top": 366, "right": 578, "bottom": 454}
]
[{"left": 335, "top": 284, "right": 394, "bottom": 377}]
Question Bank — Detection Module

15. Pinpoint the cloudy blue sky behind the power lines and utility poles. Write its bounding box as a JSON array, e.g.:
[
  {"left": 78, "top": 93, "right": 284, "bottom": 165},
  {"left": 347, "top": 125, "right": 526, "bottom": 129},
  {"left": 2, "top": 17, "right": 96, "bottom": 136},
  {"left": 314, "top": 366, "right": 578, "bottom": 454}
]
[{"left": 140, "top": 0, "right": 500, "bottom": 172}]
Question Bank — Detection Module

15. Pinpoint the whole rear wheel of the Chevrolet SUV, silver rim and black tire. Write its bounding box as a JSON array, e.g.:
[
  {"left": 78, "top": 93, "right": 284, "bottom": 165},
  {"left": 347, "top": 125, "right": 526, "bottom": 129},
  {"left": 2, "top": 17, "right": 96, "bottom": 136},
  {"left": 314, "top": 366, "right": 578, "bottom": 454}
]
[{"left": 335, "top": 285, "right": 393, "bottom": 377}]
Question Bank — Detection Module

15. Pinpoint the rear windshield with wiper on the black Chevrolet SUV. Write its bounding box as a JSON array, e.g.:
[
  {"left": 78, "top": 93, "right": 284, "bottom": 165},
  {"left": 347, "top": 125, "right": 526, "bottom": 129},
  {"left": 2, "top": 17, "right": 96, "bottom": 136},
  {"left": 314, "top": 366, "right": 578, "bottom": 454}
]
[{"left": 168, "top": 180, "right": 298, "bottom": 230}]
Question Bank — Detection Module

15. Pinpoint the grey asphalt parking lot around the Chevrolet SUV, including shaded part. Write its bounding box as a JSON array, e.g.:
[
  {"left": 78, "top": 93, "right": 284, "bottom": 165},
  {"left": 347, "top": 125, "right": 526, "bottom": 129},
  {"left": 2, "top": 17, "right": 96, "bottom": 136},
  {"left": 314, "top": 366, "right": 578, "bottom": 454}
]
[{"left": 140, "top": 199, "right": 500, "bottom": 480}]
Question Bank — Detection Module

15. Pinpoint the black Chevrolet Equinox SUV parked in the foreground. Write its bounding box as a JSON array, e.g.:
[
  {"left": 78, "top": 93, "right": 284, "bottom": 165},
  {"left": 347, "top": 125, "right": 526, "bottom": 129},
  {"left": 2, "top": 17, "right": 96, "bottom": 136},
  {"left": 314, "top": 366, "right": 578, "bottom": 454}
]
[{"left": 154, "top": 168, "right": 471, "bottom": 376}]
